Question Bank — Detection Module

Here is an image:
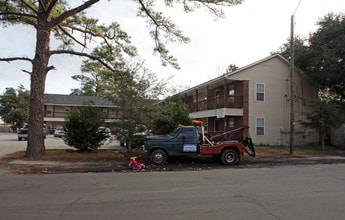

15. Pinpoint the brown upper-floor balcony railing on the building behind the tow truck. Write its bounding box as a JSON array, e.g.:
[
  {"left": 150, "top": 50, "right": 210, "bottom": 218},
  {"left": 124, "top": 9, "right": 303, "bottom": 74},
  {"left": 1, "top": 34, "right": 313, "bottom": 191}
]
[{"left": 186, "top": 96, "right": 243, "bottom": 112}]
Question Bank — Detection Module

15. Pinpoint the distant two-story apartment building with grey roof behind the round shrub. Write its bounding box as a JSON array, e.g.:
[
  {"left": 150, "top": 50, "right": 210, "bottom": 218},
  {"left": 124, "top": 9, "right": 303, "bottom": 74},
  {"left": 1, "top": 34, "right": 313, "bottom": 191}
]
[{"left": 44, "top": 94, "right": 119, "bottom": 131}]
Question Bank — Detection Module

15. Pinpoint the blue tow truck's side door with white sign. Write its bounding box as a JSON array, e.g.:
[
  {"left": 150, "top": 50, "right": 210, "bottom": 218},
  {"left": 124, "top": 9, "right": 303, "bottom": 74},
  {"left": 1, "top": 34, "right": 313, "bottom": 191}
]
[{"left": 175, "top": 129, "right": 198, "bottom": 155}]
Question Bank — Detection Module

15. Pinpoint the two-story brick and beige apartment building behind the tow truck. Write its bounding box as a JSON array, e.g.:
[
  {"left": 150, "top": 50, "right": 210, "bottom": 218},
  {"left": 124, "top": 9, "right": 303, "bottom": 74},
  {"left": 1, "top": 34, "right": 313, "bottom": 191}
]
[{"left": 180, "top": 54, "right": 318, "bottom": 145}]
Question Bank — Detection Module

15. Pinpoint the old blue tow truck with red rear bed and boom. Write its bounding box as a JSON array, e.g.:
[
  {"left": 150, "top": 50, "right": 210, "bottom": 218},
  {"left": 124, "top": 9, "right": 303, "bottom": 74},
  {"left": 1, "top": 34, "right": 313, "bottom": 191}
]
[{"left": 144, "top": 121, "right": 255, "bottom": 165}]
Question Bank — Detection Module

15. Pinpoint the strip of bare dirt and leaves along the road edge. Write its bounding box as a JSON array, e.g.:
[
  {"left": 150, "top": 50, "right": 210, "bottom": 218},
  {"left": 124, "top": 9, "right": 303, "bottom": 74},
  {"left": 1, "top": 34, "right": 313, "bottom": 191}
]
[{"left": 0, "top": 146, "right": 345, "bottom": 174}]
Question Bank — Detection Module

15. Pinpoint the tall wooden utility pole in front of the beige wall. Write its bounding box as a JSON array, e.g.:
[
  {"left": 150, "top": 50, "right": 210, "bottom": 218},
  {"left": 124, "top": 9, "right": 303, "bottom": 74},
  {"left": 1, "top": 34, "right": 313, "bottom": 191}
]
[{"left": 289, "top": 15, "right": 295, "bottom": 156}]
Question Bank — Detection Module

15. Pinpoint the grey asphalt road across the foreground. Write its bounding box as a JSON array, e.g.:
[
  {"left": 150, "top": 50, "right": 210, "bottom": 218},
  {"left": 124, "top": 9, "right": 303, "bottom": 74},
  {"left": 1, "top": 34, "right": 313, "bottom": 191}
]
[{"left": 0, "top": 164, "right": 345, "bottom": 220}]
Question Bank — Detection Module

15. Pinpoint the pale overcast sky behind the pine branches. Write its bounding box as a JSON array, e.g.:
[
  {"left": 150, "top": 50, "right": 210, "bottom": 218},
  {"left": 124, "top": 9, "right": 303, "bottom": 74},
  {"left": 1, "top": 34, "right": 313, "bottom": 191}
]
[{"left": 0, "top": 0, "right": 345, "bottom": 94}]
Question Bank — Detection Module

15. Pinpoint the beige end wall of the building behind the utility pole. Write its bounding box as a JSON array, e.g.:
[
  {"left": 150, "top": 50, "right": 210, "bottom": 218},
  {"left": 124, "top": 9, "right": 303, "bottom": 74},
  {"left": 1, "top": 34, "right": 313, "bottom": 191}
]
[{"left": 229, "top": 57, "right": 317, "bottom": 145}]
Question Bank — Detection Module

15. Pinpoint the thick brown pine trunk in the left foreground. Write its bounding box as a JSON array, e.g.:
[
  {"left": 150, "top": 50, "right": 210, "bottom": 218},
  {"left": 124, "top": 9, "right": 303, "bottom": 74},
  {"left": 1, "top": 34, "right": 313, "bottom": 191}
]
[{"left": 25, "top": 9, "right": 51, "bottom": 157}]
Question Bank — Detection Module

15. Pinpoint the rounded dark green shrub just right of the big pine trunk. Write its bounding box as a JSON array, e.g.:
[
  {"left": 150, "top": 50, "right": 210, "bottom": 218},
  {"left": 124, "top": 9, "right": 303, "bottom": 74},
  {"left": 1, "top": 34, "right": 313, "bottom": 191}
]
[{"left": 64, "top": 105, "right": 108, "bottom": 150}]
